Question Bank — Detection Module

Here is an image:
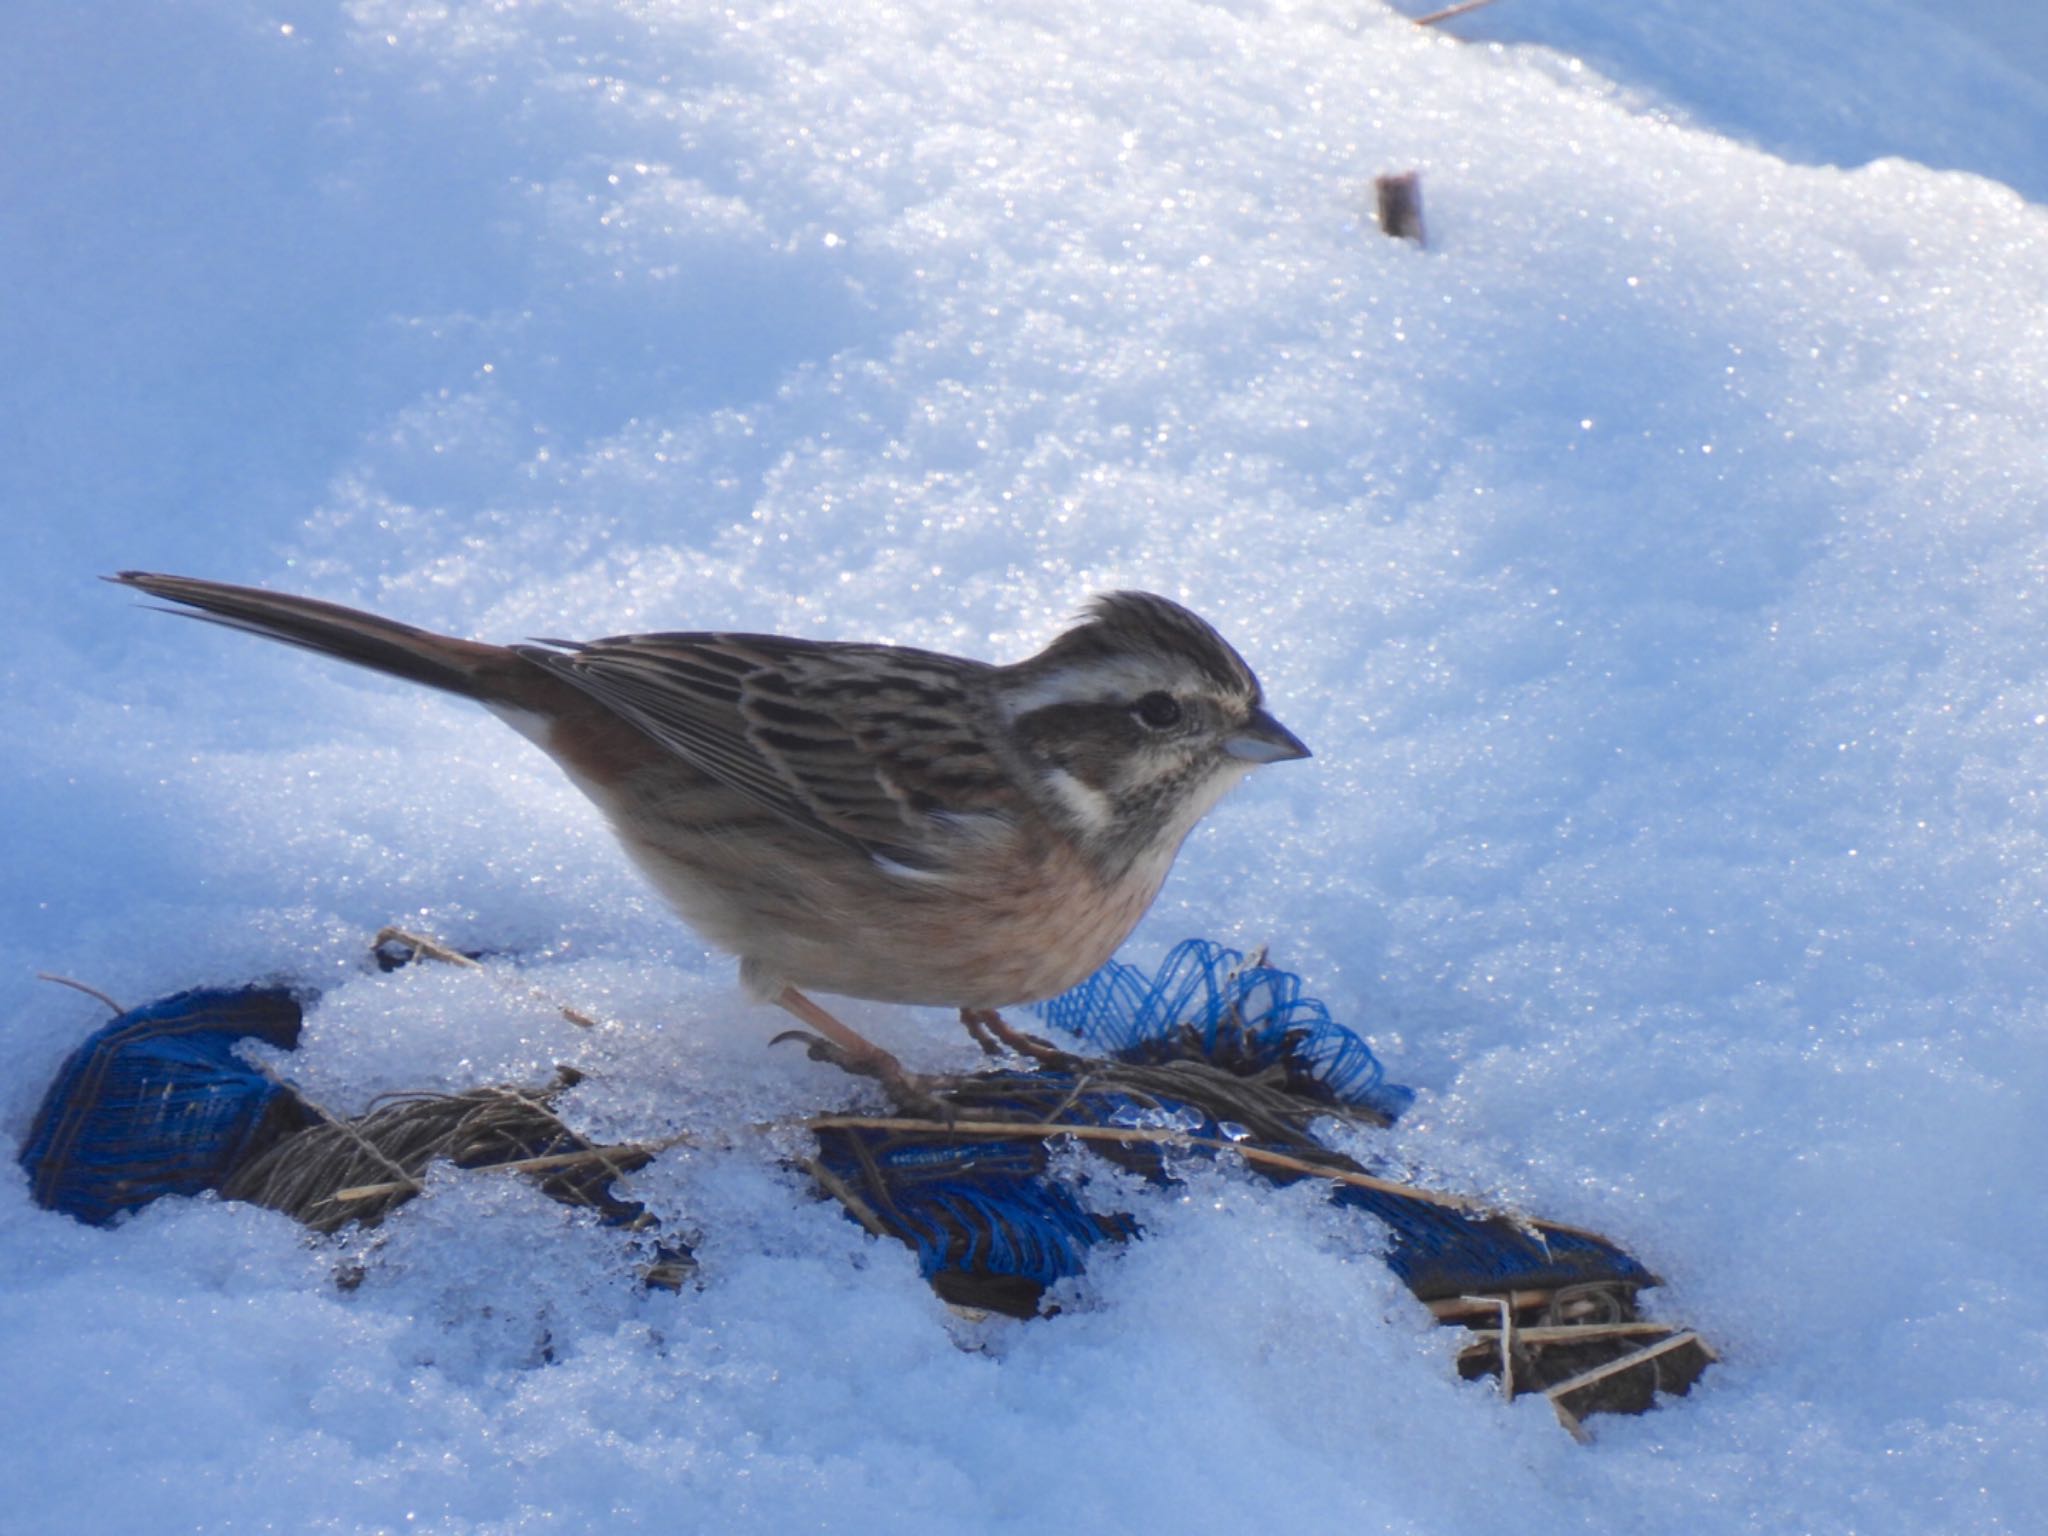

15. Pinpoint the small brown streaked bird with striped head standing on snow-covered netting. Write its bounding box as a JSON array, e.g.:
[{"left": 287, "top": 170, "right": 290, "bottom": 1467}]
[{"left": 109, "top": 571, "right": 1309, "bottom": 1087}]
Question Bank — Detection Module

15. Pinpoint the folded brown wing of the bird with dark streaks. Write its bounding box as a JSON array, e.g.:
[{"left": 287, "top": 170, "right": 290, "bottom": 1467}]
[{"left": 518, "top": 635, "right": 1018, "bottom": 870}]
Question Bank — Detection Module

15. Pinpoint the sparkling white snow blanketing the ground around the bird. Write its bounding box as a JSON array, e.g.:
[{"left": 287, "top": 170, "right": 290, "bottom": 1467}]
[{"left": 0, "top": 0, "right": 2048, "bottom": 1536}]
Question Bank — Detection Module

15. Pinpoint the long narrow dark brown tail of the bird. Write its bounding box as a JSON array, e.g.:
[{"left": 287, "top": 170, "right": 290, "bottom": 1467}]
[{"left": 106, "top": 571, "right": 512, "bottom": 702}]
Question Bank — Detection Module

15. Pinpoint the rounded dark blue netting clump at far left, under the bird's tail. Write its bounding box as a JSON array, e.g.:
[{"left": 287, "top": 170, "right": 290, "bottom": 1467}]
[{"left": 20, "top": 987, "right": 309, "bottom": 1225}]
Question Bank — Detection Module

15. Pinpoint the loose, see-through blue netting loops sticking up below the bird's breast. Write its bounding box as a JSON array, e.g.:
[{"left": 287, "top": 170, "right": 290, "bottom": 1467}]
[{"left": 1036, "top": 938, "right": 1415, "bottom": 1120}]
